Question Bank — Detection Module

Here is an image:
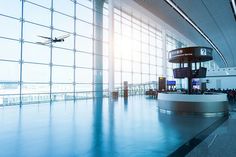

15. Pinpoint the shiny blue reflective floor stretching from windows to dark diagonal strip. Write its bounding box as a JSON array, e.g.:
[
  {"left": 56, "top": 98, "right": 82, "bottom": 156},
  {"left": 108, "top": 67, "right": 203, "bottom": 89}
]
[{"left": 0, "top": 96, "right": 218, "bottom": 157}]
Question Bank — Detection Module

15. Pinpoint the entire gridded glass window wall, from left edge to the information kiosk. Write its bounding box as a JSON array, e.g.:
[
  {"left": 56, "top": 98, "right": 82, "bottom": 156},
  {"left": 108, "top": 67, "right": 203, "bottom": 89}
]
[{"left": 0, "top": 0, "right": 192, "bottom": 105}]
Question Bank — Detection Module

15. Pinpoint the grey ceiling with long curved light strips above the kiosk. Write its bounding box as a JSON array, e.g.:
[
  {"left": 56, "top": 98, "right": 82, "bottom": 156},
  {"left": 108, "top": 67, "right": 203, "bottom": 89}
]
[{"left": 134, "top": 0, "right": 236, "bottom": 67}]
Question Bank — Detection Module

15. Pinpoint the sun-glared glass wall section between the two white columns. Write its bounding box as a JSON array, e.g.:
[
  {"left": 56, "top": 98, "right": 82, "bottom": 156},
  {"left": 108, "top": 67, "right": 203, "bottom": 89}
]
[{"left": 114, "top": 9, "right": 163, "bottom": 95}]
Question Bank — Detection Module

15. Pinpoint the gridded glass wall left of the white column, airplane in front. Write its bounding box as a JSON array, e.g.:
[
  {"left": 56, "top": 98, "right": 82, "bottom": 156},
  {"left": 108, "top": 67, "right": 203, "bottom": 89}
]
[{"left": 0, "top": 0, "right": 108, "bottom": 105}]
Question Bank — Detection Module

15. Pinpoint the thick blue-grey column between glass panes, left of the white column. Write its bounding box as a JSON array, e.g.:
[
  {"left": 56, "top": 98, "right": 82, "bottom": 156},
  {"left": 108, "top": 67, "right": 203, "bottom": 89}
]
[{"left": 93, "top": 0, "right": 105, "bottom": 98}]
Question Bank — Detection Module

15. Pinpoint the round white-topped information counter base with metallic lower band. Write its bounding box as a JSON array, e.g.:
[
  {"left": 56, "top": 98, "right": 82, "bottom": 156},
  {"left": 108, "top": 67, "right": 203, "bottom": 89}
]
[{"left": 158, "top": 93, "right": 228, "bottom": 116}]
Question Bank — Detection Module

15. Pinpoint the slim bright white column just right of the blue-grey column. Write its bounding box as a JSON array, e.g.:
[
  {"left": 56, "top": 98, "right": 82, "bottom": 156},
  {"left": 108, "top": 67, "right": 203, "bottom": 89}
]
[{"left": 108, "top": 0, "right": 115, "bottom": 96}]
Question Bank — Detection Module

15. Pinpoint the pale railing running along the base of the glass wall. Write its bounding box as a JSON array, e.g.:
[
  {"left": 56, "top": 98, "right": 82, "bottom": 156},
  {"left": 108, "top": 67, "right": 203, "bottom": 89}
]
[{"left": 0, "top": 82, "right": 157, "bottom": 106}]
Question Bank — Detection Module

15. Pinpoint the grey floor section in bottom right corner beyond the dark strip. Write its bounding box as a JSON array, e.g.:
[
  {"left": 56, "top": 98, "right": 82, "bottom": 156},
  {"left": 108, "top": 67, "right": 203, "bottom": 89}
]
[{"left": 187, "top": 104, "right": 236, "bottom": 157}]
